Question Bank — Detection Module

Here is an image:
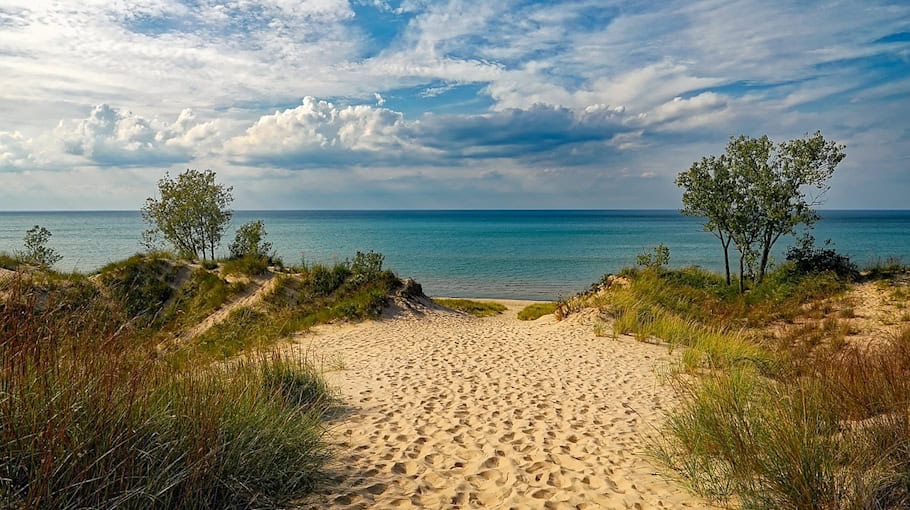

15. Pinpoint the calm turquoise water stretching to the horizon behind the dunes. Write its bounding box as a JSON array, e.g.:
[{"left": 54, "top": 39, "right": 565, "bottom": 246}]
[{"left": 0, "top": 210, "right": 910, "bottom": 299}]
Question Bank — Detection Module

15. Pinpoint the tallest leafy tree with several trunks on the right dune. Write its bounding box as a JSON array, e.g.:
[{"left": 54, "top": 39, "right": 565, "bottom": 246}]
[{"left": 676, "top": 132, "right": 845, "bottom": 291}]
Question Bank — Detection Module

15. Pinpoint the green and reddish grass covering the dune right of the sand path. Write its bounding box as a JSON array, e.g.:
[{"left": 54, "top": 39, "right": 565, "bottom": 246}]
[{"left": 589, "top": 267, "right": 910, "bottom": 509}]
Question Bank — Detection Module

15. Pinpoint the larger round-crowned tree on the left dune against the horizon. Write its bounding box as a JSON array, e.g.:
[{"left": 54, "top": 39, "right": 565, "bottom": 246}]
[{"left": 142, "top": 169, "right": 234, "bottom": 260}]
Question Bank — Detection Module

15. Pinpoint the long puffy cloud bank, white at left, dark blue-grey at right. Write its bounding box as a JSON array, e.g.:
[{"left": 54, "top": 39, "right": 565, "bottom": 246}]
[{"left": 225, "top": 97, "right": 637, "bottom": 168}]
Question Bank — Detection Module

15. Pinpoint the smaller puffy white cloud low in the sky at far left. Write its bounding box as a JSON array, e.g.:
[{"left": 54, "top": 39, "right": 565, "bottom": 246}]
[{"left": 55, "top": 104, "right": 219, "bottom": 166}]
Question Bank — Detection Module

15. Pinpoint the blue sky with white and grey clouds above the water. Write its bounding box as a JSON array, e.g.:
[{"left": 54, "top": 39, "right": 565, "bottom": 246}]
[{"left": 0, "top": 0, "right": 910, "bottom": 210}]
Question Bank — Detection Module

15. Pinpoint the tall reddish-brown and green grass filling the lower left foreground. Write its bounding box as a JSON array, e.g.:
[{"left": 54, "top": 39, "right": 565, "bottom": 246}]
[{"left": 0, "top": 272, "right": 331, "bottom": 509}]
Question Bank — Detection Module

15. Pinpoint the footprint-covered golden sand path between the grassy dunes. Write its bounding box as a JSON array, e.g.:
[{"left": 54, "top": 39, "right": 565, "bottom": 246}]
[{"left": 294, "top": 301, "right": 705, "bottom": 509}]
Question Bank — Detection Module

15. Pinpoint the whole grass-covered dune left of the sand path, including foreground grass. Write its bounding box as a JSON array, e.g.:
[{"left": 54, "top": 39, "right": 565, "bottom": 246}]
[{"left": 0, "top": 255, "right": 400, "bottom": 508}]
